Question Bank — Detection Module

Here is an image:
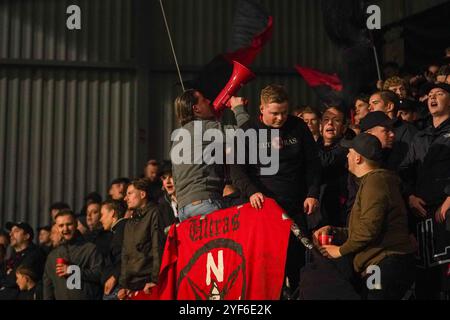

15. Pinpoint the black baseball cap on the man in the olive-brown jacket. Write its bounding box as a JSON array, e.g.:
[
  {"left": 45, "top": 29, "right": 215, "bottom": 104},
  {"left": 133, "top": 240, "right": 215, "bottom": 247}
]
[{"left": 341, "top": 133, "right": 383, "bottom": 162}]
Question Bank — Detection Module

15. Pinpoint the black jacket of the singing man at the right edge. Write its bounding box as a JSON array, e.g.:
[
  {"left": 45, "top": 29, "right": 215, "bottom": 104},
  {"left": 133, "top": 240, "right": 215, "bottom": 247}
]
[{"left": 400, "top": 119, "right": 450, "bottom": 209}]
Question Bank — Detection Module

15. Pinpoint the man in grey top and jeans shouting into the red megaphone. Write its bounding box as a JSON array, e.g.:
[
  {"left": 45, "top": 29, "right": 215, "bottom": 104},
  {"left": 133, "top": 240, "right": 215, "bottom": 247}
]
[{"left": 170, "top": 85, "right": 262, "bottom": 221}]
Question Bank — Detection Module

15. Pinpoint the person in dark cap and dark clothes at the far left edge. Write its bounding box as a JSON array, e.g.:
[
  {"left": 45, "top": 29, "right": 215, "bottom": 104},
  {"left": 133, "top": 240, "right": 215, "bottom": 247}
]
[{"left": 0, "top": 222, "right": 44, "bottom": 300}]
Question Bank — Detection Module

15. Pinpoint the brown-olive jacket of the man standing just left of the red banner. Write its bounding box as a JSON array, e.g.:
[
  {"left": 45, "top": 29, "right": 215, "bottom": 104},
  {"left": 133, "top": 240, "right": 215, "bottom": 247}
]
[{"left": 119, "top": 203, "right": 163, "bottom": 290}]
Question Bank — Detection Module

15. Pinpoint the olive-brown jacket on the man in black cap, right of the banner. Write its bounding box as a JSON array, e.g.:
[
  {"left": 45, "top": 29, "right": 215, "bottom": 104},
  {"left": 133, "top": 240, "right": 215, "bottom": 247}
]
[{"left": 334, "top": 169, "right": 414, "bottom": 273}]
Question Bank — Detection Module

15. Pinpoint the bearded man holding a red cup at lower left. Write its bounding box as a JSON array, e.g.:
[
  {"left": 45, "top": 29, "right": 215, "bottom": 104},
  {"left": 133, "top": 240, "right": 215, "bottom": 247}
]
[{"left": 43, "top": 209, "right": 104, "bottom": 300}]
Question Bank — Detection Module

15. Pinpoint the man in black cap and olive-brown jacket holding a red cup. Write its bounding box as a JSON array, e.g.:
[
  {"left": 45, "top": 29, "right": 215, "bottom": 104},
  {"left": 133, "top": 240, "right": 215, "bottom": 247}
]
[{"left": 314, "top": 133, "right": 415, "bottom": 300}]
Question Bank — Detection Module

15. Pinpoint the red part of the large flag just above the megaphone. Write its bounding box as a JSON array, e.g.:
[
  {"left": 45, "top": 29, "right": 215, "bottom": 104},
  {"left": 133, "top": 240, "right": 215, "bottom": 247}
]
[{"left": 224, "top": 16, "right": 273, "bottom": 67}]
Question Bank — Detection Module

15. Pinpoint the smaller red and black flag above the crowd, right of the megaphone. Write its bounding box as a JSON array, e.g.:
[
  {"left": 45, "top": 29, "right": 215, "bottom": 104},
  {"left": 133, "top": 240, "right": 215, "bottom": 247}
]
[{"left": 295, "top": 65, "right": 343, "bottom": 110}]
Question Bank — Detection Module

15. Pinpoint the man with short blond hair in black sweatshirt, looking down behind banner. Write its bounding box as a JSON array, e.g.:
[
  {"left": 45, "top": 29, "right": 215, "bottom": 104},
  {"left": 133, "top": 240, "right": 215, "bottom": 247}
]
[{"left": 232, "top": 84, "right": 321, "bottom": 296}]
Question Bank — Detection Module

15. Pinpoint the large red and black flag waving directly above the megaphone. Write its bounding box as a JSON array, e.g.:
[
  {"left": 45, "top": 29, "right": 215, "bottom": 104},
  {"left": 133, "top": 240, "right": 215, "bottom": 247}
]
[{"left": 186, "top": 0, "right": 273, "bottom": 101}]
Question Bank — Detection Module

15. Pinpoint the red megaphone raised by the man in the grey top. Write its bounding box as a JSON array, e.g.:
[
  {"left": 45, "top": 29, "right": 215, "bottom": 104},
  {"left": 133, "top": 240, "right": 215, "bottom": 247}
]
[{"left": 213, "top": 60, "right": 255, "bottom": 114}]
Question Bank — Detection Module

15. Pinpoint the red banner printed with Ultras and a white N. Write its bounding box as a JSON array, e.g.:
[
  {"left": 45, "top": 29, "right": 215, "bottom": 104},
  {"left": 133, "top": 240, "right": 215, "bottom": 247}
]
[{"left": 159, "top": 198, "right": 292, "bottom": 300}]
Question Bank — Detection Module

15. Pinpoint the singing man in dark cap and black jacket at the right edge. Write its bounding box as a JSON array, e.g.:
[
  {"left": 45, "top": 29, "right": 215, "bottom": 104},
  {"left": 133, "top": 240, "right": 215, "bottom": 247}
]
[{"left": 400, "top": 83, "right": 450, "bottom": 299}]
